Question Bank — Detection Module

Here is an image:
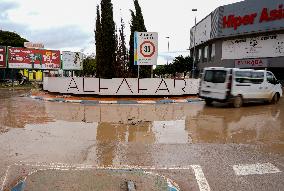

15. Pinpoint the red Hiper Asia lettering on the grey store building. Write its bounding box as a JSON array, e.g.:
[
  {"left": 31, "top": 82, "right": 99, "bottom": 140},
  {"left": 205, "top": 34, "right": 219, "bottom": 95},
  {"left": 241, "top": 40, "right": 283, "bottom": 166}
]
[{"left": 223, "top": 4, "right": 284, "bottom": 30}]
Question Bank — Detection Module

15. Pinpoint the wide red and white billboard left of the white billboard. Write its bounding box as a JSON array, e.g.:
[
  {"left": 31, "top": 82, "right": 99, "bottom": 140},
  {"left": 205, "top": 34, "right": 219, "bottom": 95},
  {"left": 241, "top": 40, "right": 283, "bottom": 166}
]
[{"left": 8, "top": 47, "right": 60, "bottom": 70}]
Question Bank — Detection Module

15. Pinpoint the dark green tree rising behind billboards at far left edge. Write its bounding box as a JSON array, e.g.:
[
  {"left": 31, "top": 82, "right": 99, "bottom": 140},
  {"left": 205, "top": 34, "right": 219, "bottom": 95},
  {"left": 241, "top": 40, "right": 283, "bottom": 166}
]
[{"left": 0, "top": 30, "right": 28, "bottom": 47}]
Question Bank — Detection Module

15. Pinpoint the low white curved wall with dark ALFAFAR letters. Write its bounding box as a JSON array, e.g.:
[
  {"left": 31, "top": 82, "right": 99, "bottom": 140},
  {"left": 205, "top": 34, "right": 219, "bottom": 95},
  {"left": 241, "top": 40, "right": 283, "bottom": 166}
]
[{"left": 43, "top": 77, "right": 199, "bottom": 96}]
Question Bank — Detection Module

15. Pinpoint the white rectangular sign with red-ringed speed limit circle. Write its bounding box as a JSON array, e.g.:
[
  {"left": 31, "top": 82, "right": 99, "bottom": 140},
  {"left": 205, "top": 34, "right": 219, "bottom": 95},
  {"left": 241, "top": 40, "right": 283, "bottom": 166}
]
[{"left": 134, "top": 32, "right": 158, "bottom": 65}]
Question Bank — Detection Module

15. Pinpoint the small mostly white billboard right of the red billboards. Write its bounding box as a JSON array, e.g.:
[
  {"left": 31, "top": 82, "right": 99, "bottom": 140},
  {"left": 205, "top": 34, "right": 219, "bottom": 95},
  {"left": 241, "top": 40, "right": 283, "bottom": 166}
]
[{"left": 62, "top": 51, "right": 83, "bottom": 70}]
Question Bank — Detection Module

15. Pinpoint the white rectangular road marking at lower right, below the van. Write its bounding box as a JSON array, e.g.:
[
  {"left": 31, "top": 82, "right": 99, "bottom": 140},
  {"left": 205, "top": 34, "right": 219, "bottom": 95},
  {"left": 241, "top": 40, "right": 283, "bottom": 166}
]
[{"left": 233, "top": 163, "right": 281, "bottom": 176}]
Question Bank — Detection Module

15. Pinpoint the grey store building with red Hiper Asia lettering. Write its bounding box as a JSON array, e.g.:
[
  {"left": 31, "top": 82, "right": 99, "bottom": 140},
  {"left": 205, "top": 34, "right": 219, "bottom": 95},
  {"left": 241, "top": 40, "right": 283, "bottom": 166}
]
[{"left": 190, "top": 0, "right": 284, "bottom": 79}]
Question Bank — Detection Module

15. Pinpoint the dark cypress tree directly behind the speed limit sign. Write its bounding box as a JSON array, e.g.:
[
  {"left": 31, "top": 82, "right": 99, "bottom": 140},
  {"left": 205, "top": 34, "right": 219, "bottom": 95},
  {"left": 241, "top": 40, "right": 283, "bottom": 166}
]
[{"left": 129, "top": 0, "right": 152, "bottom": 78}]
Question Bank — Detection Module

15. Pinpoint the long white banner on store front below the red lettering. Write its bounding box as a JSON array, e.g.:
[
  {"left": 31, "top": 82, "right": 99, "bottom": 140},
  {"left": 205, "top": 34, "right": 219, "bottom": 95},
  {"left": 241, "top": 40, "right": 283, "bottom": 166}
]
[{"left": 222, "top": 34, "right": 284, "bottom": 59}]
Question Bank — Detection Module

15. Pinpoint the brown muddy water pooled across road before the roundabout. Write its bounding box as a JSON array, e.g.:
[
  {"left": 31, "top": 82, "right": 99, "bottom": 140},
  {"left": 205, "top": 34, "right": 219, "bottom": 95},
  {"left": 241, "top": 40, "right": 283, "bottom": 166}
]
[{"left": 0, "top": 90, "right": 284, "bottom": 165}]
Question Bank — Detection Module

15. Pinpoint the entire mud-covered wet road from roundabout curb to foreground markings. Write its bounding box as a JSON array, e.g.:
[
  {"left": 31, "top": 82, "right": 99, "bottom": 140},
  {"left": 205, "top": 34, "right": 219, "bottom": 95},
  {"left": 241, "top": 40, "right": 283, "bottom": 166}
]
[{"left": 0, "top": 90, "right": 284, "bottom": 191}]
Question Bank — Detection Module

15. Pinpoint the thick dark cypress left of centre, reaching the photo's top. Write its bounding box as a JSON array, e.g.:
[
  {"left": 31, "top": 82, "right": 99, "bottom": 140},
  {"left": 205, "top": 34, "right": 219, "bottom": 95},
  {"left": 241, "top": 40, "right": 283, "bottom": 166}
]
[{"left": 100, "top": 0, "right": 116, "bottom": 78}]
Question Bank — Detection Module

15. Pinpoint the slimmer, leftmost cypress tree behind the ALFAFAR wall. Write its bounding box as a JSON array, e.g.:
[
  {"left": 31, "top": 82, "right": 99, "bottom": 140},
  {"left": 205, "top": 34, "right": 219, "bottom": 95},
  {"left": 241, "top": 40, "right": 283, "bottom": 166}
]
[{"left": 95, "top": 5, "right": 104, "bottom": 78}]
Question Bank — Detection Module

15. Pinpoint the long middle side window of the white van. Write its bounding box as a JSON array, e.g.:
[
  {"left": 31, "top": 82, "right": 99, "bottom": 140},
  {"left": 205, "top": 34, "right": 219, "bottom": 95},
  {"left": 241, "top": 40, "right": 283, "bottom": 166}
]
[{"left": 235, "top": 71, "right": 264, "bottom": 84}]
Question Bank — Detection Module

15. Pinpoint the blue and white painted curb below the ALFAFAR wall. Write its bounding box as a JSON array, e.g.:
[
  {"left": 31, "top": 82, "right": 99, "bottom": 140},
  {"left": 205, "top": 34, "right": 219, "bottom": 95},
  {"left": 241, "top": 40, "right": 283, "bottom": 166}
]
[{"left": 28, "top": 96, "right": 203, "bottom": 105}]
